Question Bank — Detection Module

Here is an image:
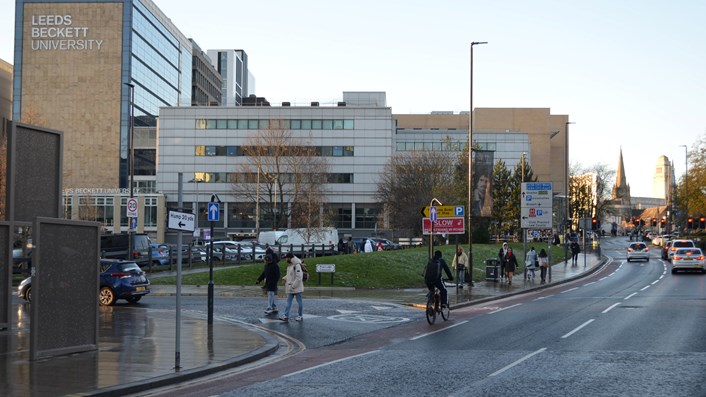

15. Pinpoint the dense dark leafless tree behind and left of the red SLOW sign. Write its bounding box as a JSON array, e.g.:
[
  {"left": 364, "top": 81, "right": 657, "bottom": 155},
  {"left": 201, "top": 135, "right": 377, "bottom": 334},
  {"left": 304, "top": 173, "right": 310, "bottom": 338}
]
[{"left": 376, "top": 150, "right": 455, "bottom": 235}]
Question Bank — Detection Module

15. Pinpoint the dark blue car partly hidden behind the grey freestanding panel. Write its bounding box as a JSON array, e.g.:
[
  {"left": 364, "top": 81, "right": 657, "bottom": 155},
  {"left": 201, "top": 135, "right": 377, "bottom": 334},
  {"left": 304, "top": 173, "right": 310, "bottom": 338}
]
[{"left": 17, "top": 259, "right": 150, "bottom": 306}]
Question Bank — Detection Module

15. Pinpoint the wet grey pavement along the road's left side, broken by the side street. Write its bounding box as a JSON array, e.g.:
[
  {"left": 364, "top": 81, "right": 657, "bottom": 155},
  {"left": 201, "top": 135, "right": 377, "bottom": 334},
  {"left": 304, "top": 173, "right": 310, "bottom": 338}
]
[{"left": 0, "top": 249, "right": 605, "bottom": 396}]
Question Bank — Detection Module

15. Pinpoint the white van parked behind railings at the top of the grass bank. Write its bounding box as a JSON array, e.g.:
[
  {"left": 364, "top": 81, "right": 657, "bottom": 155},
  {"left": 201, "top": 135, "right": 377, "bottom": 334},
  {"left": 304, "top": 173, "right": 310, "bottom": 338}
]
[{"left": 277, "top": 227, "right": 338, "bottom": 255}]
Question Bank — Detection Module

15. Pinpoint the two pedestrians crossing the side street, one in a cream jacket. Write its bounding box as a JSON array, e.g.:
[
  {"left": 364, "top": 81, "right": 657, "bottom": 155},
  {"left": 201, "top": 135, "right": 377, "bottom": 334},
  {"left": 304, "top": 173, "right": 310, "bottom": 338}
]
[{"left": 255, "top": 248, "right": 304, "bottom": 321}]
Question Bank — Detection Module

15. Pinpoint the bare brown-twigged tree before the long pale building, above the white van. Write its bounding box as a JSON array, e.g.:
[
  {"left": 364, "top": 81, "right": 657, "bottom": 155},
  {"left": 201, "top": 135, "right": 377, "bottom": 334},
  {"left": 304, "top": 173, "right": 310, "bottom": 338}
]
[{"left": 231, "top": 120, "right": 329, "bottom": 229}]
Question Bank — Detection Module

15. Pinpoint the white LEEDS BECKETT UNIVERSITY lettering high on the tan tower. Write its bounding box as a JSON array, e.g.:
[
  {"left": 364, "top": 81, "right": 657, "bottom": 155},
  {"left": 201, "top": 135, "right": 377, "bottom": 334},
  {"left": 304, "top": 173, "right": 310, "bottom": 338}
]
[{"left": 31, "top": 15, "right": 104, "bottom": 51}]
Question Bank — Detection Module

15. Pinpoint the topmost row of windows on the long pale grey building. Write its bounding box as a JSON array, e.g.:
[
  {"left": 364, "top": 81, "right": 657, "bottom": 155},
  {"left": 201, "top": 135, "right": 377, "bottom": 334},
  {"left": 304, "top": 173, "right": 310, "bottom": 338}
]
[{"left": 196, "top": 119, "right": 355, "bottom": 130}]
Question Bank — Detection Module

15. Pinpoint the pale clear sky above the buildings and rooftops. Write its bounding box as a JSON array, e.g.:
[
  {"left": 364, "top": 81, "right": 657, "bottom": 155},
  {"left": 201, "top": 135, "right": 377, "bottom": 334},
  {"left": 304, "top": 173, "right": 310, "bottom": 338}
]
[{"left": 0, "top": 0, "right": 706, "bottom": 197}]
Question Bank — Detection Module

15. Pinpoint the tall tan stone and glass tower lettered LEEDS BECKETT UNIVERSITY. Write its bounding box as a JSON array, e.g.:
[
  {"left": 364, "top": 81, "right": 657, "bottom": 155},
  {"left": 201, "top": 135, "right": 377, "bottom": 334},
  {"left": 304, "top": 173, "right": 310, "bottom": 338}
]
[{"left": 13, "top": 0, "right": 192, "bottom": 194}]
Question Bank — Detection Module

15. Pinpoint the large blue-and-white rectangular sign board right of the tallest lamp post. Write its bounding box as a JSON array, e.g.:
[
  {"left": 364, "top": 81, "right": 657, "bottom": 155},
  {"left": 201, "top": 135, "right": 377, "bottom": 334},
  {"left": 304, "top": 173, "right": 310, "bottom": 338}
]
[{"left": 520, "top": 182, "right": 553, "bottom": 229}]
